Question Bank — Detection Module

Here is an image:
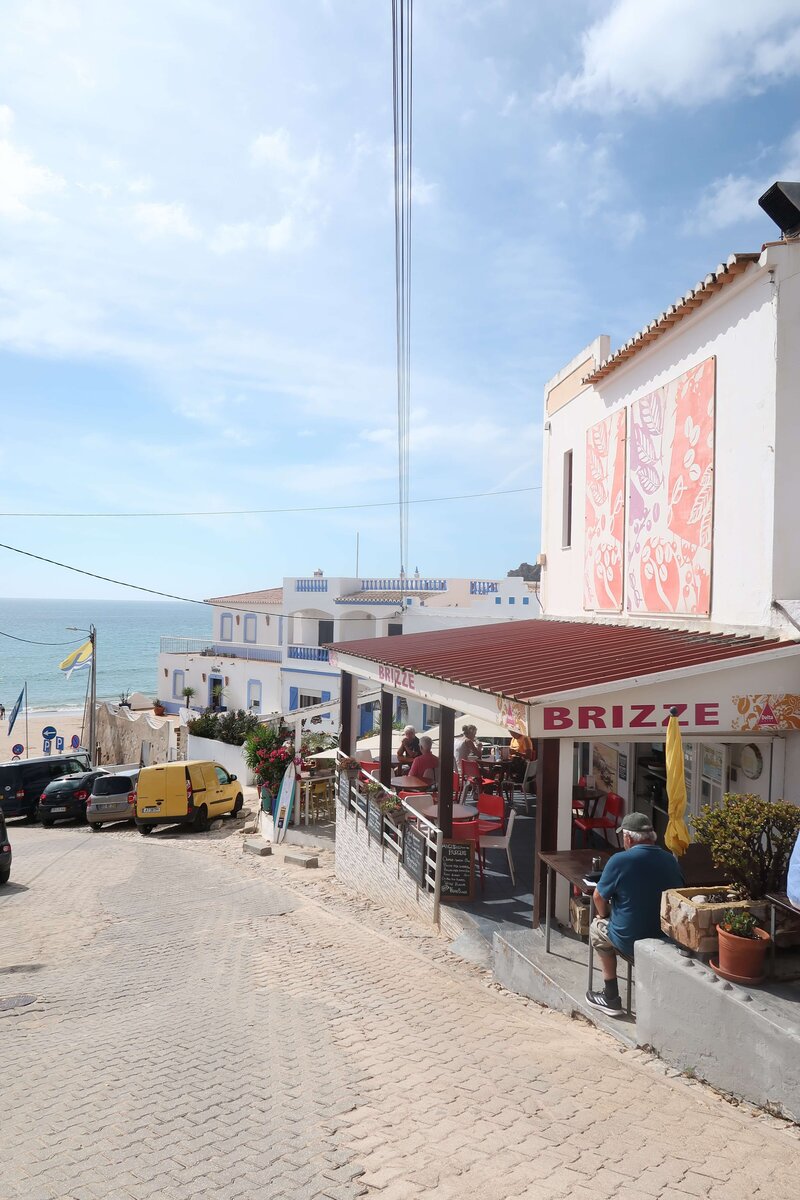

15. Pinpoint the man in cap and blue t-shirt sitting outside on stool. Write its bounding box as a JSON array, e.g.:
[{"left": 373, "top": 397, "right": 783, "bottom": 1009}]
[{"left": 587, "top": 812, "right": 684, "bottom": 1016}]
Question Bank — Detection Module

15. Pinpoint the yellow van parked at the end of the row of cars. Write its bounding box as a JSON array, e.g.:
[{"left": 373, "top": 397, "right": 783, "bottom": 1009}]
[{"left": 136, "top": 760, "right": 243, "bottom": 834}]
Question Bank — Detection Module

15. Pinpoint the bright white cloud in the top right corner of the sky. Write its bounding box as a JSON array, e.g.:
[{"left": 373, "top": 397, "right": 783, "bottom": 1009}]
[{"left": 545, "top": 0, "right": 800, "bottom": 112}]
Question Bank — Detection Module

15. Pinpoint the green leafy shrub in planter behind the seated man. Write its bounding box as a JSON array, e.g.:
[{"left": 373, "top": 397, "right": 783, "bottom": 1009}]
[{"left": 692, "top": 793, "right": 800, "bottom": 900}]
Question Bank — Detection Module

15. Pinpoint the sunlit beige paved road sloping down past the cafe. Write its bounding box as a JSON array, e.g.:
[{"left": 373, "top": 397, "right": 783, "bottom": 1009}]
[{"left": 0, "top": 824, "right": 800, "bottom": 1200}]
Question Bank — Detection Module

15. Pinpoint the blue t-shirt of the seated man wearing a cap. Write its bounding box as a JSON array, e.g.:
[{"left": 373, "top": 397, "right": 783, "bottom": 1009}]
[{"left": 597, "top": 845, "right": 684, "bottom": 955}]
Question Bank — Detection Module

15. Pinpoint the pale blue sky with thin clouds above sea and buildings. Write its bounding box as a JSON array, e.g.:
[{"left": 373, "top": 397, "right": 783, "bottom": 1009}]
[{"left": 0, "top": 0, "right": 800, "bottom": 599}]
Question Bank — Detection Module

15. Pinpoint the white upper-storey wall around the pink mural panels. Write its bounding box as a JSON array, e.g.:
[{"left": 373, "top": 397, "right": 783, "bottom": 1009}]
[{"left": 542, "top": 247, "right": 782, "bottom": 626}]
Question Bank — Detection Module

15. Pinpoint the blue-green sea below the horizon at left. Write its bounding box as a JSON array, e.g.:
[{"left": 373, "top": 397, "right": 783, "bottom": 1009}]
[{"left": 0, "top": 599, "right": 212, "bottom": 712}]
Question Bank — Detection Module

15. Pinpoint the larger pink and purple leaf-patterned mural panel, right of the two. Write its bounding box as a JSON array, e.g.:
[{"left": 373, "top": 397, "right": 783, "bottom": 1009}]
[{"left": 627, "top": 359, "right": 716, "bottom": 616}]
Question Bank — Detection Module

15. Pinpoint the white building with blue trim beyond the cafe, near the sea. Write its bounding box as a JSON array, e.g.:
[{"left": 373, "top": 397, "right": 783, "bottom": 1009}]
[{"left": 158, "top": 572, "right": 539, "bottom": 731}]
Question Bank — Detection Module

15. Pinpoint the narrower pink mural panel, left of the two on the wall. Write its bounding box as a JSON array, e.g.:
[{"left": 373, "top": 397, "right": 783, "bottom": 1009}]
[{"left": 583, "top": 408, "right": 625, "bottom": 612}]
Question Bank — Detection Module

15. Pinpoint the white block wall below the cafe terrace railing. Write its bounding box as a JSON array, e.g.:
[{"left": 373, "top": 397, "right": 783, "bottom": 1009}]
[{"left": 336, "top": 804, "right": 463, "bottom": 937}]
